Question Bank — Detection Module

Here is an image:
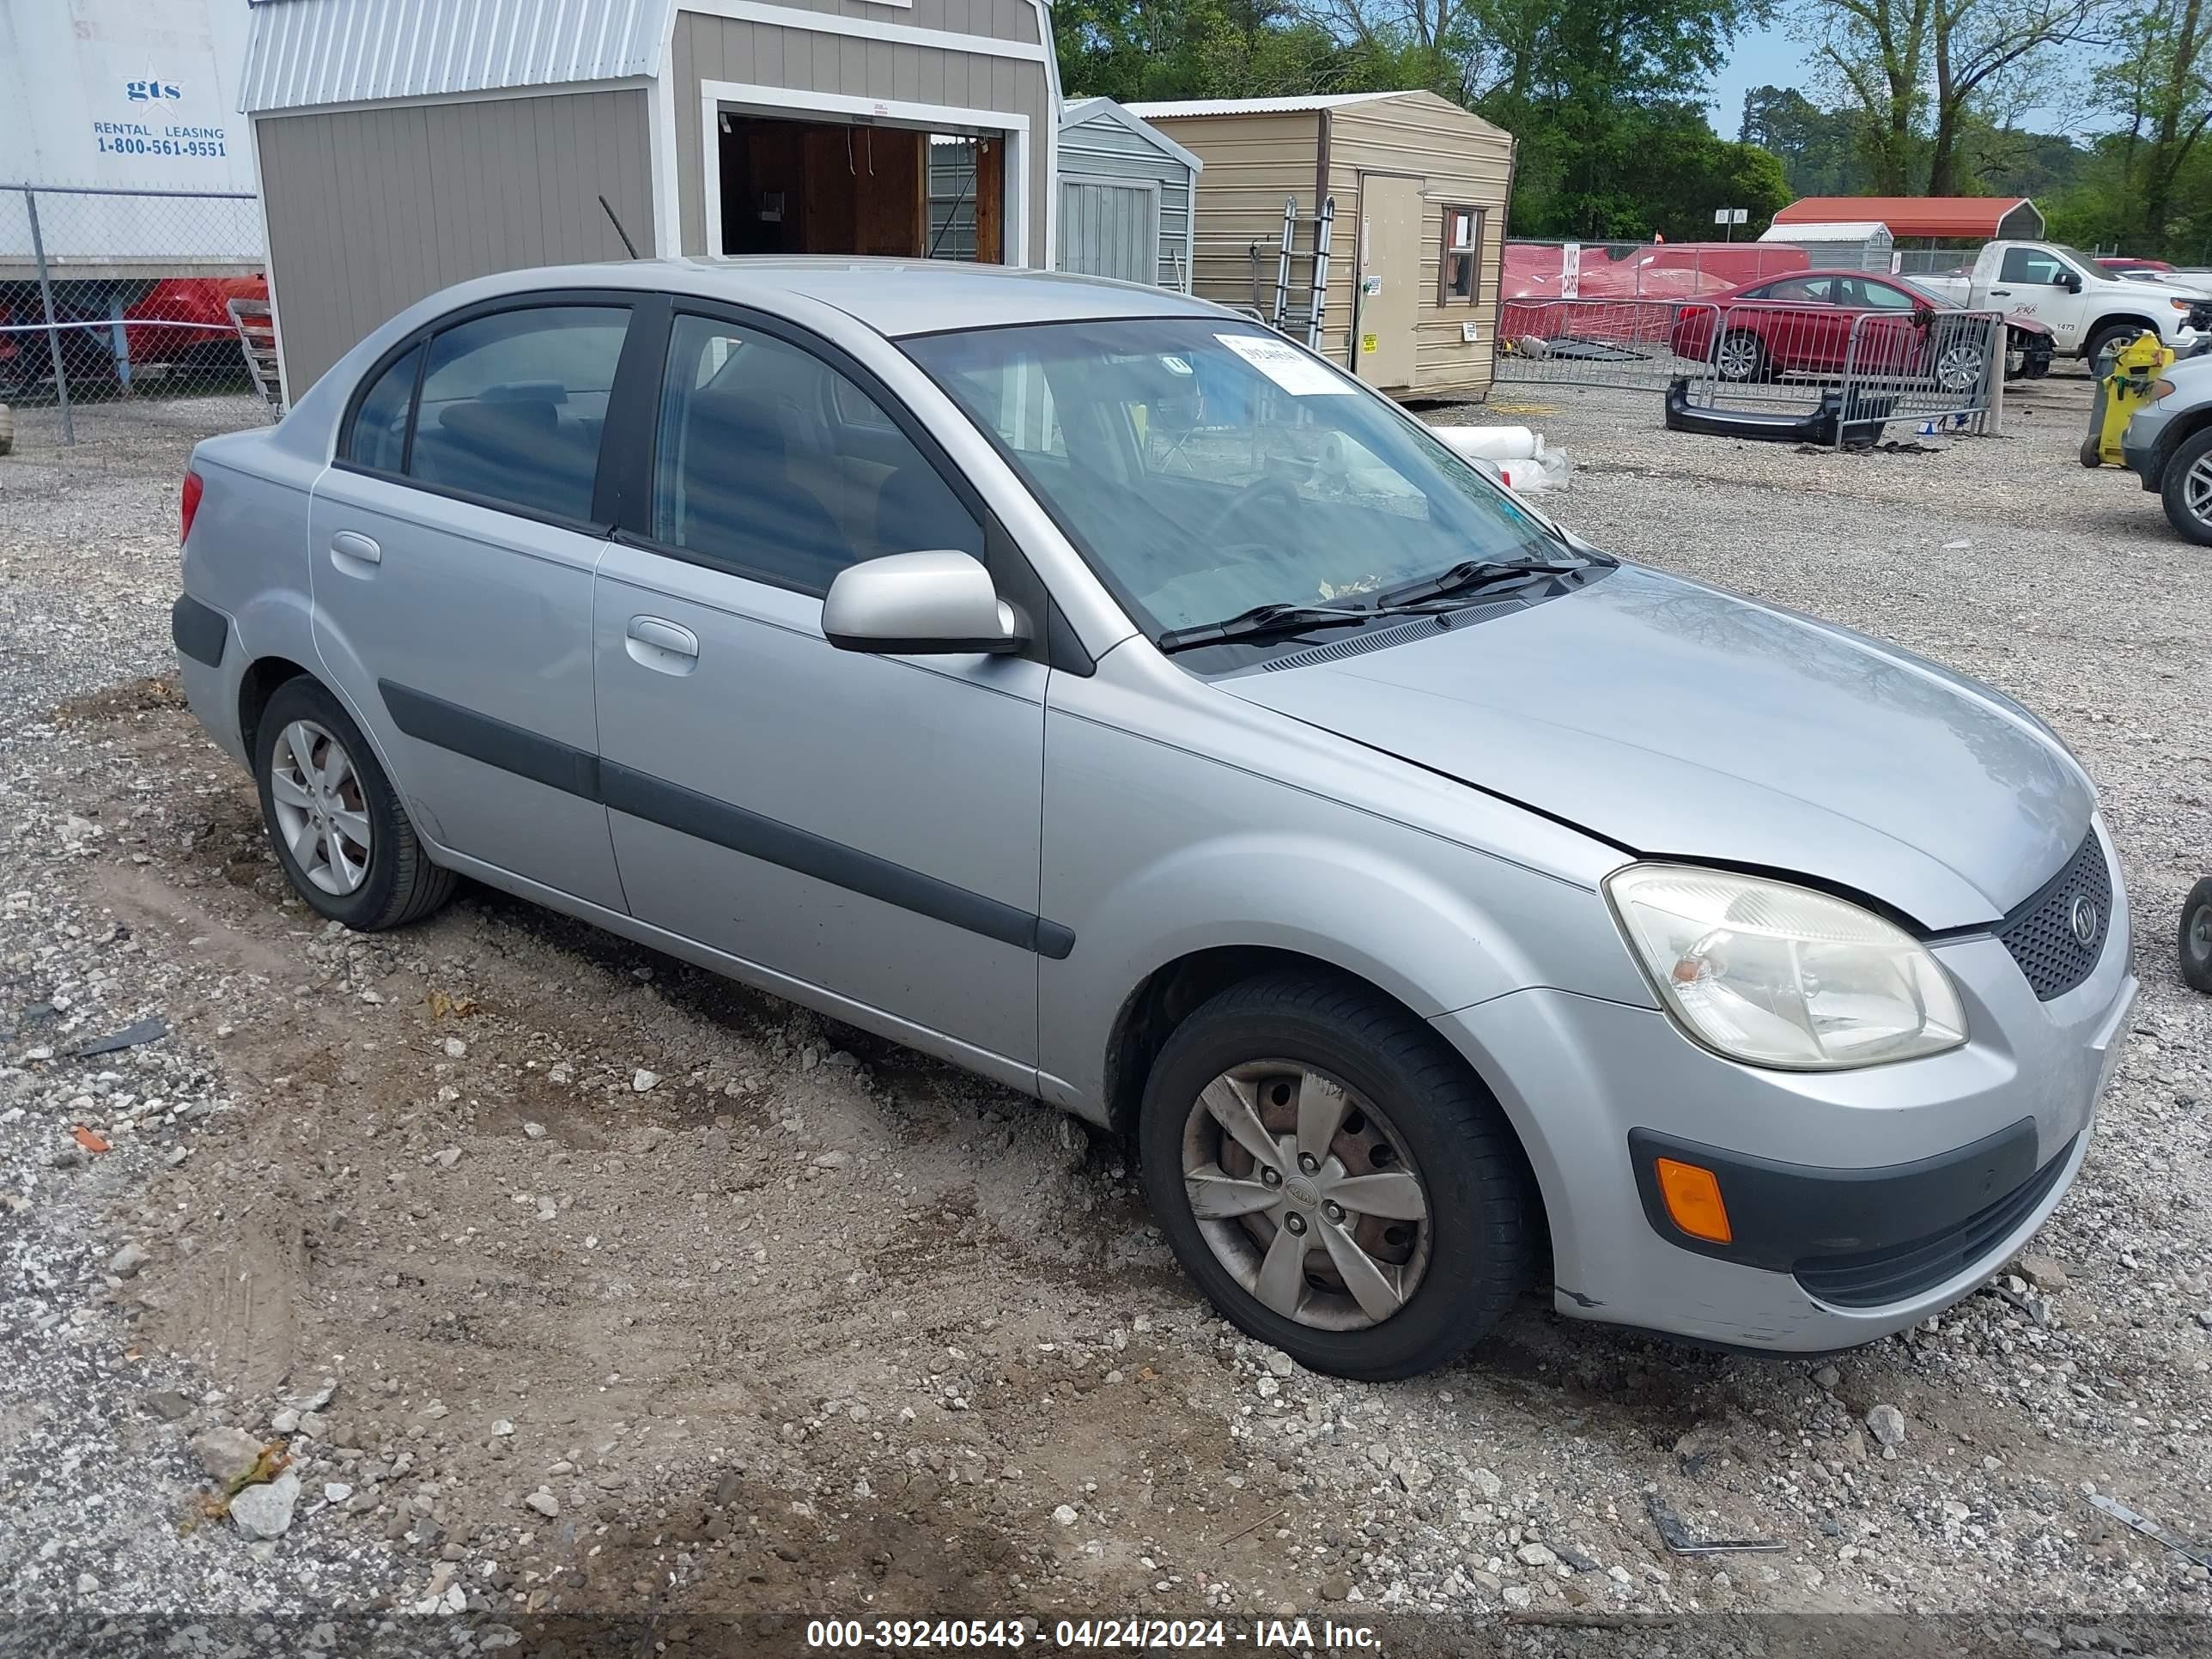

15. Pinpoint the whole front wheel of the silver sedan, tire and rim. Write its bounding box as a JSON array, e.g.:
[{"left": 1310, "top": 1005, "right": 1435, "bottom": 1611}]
[{"left": 1139, "top": 975, "right": 1533, "bottom": 1382}]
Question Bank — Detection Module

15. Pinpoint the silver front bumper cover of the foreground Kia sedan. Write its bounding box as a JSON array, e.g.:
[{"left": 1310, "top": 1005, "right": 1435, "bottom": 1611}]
[{"left": 1436, "top": 825, "right": 2136, "bottom": 1352}]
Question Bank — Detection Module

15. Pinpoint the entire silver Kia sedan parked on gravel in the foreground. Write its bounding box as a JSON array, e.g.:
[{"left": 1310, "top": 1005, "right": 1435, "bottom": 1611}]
[{"left": 175, "top": 261, "right": 2135, "bottom": 1378}]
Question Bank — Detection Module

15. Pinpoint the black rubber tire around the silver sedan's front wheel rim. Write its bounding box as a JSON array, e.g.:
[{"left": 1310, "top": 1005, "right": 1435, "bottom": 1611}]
[{"left": 1137, "top": 975, "right": 1535, "bottom": 1382}]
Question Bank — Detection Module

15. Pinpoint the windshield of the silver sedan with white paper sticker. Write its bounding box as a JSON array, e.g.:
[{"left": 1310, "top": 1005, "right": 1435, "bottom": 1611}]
[{"left": 902, "top": 316, "right": 1568, "bottom": 637}]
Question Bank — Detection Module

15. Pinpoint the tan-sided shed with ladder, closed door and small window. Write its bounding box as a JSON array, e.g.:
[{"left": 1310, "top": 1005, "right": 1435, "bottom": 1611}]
[{"left": 1128, "top": 93, "right": 1513, "bottom": 398}]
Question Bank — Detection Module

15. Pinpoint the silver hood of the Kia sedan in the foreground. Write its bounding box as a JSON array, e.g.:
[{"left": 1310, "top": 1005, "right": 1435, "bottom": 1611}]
[{"left": 1217, "top": 564, "right": 2094, "bottom": 931}]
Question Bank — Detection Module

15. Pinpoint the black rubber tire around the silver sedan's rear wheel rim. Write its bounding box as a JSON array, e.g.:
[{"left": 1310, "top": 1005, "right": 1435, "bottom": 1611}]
[{"left": 254, "top": 675, "right": 460, "bottom": 933}]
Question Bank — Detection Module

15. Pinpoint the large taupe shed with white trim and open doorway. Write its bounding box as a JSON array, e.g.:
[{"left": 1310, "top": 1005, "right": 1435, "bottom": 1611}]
[{"left": 241, "top": 0, "right": 1060, "bottom": 396}]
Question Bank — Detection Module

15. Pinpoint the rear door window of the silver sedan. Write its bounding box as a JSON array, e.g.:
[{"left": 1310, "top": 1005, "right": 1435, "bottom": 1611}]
[{"left": 407, "top": 305, "right": 630, "bottom": 522}]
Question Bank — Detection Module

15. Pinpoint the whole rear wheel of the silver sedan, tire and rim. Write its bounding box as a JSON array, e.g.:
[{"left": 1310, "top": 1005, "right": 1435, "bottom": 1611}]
[{"left": 254, "top": 677, "right": 456, "bottom": 933}]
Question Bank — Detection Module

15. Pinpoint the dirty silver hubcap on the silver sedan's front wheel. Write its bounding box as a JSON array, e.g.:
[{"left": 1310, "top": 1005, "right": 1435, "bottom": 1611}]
[{"left": 1183, "top": 1060, "right": 1429, "bottom": 1332}]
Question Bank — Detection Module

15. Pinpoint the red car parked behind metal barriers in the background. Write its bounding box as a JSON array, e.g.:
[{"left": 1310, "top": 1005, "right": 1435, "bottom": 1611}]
[{"left": 1668, "top": 270, "right": 2053, "bottom": 389}]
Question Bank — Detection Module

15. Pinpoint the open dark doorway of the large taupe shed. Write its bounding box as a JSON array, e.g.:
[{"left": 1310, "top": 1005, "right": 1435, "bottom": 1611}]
[{"left": 714, "top": 111, "right": 1006, "bottom": 264}]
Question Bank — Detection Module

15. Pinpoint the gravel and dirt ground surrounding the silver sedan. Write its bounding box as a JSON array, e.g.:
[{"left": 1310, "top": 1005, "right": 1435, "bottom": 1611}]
[{"left": 0, "top": 378, "right": 2212, "bottom": 1655}]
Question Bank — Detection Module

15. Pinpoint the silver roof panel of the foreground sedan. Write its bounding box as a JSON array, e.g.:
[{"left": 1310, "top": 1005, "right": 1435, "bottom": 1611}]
[{"left": 473, "top": 254, "right": 1228, "bottom": 338}]
